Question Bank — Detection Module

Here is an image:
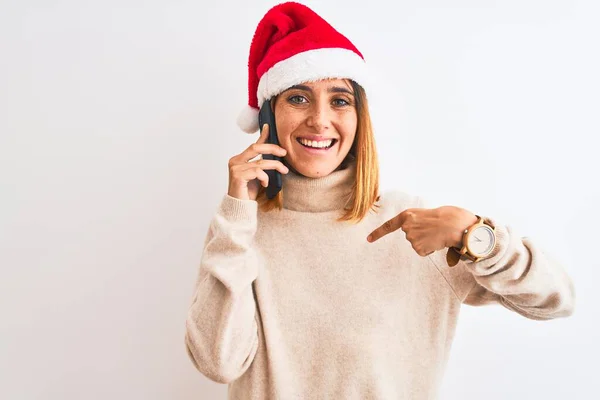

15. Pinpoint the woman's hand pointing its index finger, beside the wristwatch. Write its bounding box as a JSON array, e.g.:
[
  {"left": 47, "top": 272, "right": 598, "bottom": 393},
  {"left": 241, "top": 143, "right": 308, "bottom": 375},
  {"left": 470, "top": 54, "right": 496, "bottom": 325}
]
[{"left": 367, "top": 206, "right": 477, "bottom": 256}]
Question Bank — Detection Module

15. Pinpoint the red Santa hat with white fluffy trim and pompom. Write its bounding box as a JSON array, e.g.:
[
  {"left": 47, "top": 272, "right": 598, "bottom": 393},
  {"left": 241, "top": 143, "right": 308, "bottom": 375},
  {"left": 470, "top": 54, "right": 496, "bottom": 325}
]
[{"left": 237, "top": 2, "right": 367, "bottom": 133}]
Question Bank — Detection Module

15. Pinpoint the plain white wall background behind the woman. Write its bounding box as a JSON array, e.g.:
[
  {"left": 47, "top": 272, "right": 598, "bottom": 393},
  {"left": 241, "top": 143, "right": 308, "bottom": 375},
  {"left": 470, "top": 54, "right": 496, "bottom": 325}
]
[{"left": 0, "top": 0, "right": 600, "bottom": 400}]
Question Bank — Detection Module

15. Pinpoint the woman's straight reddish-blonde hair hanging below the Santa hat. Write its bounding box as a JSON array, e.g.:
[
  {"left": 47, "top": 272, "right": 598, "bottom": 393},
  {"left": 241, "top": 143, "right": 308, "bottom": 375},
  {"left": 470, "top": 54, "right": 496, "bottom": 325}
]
[{"left": 256, "top": 80, "right": 379, "bottom": 223}]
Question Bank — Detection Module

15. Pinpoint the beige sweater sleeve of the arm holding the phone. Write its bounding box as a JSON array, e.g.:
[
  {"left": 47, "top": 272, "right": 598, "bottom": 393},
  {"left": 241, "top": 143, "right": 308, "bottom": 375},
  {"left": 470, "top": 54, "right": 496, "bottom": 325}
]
[{"left": 185, "top": 194, "right": 259, "bottom": 383}]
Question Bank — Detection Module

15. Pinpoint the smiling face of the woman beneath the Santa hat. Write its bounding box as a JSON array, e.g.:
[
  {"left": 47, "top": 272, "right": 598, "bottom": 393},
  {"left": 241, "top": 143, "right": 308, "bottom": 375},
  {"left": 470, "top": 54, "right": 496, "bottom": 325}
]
[{"left": 273, "top": 79, "right": 358, "bottom": 178}]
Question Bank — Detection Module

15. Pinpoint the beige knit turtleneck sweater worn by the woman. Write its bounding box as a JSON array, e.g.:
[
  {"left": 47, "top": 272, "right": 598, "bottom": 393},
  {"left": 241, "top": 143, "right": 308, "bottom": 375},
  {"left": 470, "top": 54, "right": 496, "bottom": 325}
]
[{"left": 185, "top": 160, "right": 574, "bottom": 400}]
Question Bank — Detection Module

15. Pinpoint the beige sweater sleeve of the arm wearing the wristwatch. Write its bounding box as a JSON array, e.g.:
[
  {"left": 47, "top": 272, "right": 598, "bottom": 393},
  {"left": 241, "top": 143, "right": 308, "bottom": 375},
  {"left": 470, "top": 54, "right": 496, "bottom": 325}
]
[{"left": 417, "top": 197, "right": 575, "bottom": 320}]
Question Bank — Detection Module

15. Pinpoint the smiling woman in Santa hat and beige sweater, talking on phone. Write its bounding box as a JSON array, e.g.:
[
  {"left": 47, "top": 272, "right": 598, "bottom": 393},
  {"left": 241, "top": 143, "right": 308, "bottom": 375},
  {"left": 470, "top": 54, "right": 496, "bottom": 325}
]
[{"left": 186, "top": 3, "right": 574, "bottom": 400}]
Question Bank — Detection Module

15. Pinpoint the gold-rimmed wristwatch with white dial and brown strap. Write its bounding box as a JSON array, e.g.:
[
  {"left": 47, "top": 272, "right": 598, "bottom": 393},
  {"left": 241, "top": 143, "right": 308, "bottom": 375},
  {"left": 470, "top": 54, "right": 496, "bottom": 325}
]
[{"left": 446, "top": 215, "right": 496, "bottom": 267}]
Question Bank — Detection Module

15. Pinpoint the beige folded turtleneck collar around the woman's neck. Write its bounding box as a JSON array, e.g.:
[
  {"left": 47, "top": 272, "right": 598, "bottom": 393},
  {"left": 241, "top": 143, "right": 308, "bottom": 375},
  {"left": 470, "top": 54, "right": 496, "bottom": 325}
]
[{"left": 281, "top": 160, "right": 356, "bottom": 212}]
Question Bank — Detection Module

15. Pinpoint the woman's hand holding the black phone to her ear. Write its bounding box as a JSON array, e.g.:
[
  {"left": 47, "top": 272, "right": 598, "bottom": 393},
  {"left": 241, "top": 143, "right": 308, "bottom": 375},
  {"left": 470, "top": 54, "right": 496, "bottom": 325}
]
[{"left": 227, "top": 124, "right": 289, "bottom": 200}]
